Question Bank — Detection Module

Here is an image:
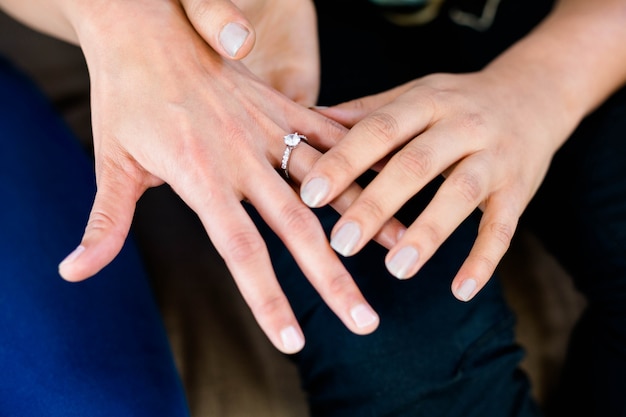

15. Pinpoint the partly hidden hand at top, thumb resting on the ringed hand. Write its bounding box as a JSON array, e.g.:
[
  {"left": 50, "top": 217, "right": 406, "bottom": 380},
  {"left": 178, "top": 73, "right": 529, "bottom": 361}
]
[{"left": 181, "top": 0, "right": 320, "bottom": 106}]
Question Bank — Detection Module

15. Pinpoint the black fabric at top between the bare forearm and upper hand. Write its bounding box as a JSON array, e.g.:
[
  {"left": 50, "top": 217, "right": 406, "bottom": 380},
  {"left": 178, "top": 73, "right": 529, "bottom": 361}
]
[{"left": 315, "top": 0, "right": 552, "bottom": 105}]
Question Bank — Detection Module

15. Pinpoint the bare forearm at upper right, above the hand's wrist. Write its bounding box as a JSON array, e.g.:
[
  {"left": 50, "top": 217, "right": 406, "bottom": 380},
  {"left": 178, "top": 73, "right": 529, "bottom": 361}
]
[{"left": 487, "top": 0, "right": 626, "bottom": 132}]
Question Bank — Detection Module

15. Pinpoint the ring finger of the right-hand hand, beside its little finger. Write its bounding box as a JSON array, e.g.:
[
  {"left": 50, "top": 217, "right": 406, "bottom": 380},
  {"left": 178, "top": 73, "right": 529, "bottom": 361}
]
[{"left": 386, "top": 157, "right": 489, "bottom": 279}]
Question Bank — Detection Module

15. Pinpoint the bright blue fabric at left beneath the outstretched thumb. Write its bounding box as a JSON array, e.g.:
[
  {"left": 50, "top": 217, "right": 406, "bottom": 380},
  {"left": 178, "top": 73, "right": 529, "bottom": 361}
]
[{"left": 0, "top": 59, "right": 188, "bottom": 417}]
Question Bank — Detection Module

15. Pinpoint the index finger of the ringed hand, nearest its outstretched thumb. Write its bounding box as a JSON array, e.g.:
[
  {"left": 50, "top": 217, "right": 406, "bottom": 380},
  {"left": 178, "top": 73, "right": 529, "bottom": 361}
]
[{"left": 176, "top": 176, "right": 304, "bottom": 353}]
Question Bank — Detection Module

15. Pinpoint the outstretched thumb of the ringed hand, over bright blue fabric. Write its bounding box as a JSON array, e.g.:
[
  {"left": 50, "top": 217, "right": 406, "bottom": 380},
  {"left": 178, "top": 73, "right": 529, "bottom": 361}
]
[{"left": 59, "top": 158, "right": 146, "bottom": 281}]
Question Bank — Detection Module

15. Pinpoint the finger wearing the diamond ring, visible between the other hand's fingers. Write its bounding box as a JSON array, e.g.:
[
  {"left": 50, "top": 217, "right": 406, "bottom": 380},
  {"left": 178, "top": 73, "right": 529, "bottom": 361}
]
[{"left": 289, "top": 143, "right": 406, "bottom": 249}]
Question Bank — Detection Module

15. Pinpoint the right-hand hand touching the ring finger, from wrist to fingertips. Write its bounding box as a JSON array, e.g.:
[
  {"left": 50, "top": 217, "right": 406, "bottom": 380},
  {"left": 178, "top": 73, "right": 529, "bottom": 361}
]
[{"left": 301, "top": 70, "right": 575, "bottom": 301}]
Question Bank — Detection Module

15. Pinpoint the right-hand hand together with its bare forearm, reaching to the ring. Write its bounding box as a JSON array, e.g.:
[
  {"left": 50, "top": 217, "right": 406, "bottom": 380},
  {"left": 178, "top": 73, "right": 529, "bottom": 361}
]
[{"left": 301, "top": 0, "right": 626, "bottom": 301}]
